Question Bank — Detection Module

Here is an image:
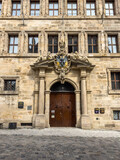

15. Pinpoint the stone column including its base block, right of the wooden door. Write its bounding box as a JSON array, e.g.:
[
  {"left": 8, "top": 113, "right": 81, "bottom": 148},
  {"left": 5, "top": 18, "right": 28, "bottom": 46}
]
[{"left": 81, "top": 69, "right": 91, "bottom": 129}]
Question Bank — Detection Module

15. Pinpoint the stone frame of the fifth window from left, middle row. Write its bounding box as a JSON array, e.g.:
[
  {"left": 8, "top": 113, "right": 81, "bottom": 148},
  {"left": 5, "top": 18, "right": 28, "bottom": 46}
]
[{"left": 86, "top": 31, "right": 101, "bottom": 56}]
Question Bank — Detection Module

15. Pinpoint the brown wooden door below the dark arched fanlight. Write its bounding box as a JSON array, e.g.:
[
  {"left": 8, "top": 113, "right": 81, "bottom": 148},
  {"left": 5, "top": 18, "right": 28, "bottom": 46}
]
[{"left": 50, "top": 93, "right": 76, "bottom": 127}]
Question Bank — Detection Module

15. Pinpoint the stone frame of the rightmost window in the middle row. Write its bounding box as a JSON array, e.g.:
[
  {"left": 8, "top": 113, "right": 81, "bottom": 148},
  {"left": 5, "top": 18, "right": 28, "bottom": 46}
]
[{"left": 106, "top": 31, "right": 120, "bottom": 56}]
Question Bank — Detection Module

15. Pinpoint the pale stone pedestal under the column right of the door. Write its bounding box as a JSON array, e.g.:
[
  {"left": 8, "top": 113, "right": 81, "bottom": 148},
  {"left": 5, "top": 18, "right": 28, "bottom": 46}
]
[{"left": 81, "top": 115, "right": 91, "bottom": 129}]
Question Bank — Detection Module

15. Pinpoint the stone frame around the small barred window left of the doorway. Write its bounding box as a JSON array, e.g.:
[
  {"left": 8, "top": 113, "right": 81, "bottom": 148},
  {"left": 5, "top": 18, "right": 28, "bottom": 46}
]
[{"left": 0, "top": 76, "right": 20, "bottom": 95}]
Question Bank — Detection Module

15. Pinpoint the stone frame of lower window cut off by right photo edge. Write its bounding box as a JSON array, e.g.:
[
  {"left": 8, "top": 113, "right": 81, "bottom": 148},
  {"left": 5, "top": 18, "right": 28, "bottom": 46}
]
[{"left": 107, "top": 68, "right": 120, "bottom": 95}]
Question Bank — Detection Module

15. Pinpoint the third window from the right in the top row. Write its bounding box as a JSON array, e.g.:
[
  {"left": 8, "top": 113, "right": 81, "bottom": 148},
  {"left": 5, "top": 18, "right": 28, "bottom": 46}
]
[{"left": 67, "top": 0, "right": 77, "bottom": 16}]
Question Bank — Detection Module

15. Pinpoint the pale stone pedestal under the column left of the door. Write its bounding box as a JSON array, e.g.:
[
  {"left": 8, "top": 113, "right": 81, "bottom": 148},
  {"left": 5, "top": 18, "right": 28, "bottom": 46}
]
[{"left": 33, "top": 114, "right": 45, "bottom": 129}]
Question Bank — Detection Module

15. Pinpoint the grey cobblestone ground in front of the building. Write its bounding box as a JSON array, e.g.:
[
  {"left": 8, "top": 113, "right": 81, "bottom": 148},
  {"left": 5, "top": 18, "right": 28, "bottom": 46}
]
[{"left": 0, "top": 129, "right": 120, "bottom": 160}]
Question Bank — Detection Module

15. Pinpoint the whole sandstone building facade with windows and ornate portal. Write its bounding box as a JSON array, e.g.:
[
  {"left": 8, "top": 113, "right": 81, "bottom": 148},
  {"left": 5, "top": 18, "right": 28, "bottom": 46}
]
[{"left": 0, "top": 0, "right": 120, "bottom": 129}]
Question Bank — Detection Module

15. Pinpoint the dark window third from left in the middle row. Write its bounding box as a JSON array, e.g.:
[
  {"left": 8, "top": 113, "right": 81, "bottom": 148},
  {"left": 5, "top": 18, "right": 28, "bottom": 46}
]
[{"left": 48, "top": 35, "right": 58, "bottom": 53}]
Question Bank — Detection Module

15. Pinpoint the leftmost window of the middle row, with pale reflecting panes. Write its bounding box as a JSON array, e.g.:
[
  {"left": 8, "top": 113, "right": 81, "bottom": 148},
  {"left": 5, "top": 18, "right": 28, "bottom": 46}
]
[{"left": 9, "top": 36, "right": 18, "bottom": 53}]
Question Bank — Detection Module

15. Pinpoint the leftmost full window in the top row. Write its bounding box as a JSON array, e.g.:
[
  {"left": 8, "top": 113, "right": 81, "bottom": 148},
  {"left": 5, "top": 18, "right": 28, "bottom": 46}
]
[{"left": 12, "top": 1, "right": 21, "bottom": 16}]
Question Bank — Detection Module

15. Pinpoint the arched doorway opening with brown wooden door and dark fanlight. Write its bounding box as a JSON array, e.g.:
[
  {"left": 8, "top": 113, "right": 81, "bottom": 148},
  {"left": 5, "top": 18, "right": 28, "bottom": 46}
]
[{"left": 50, "top": 82, "right": 76, "bottom": 127}]
